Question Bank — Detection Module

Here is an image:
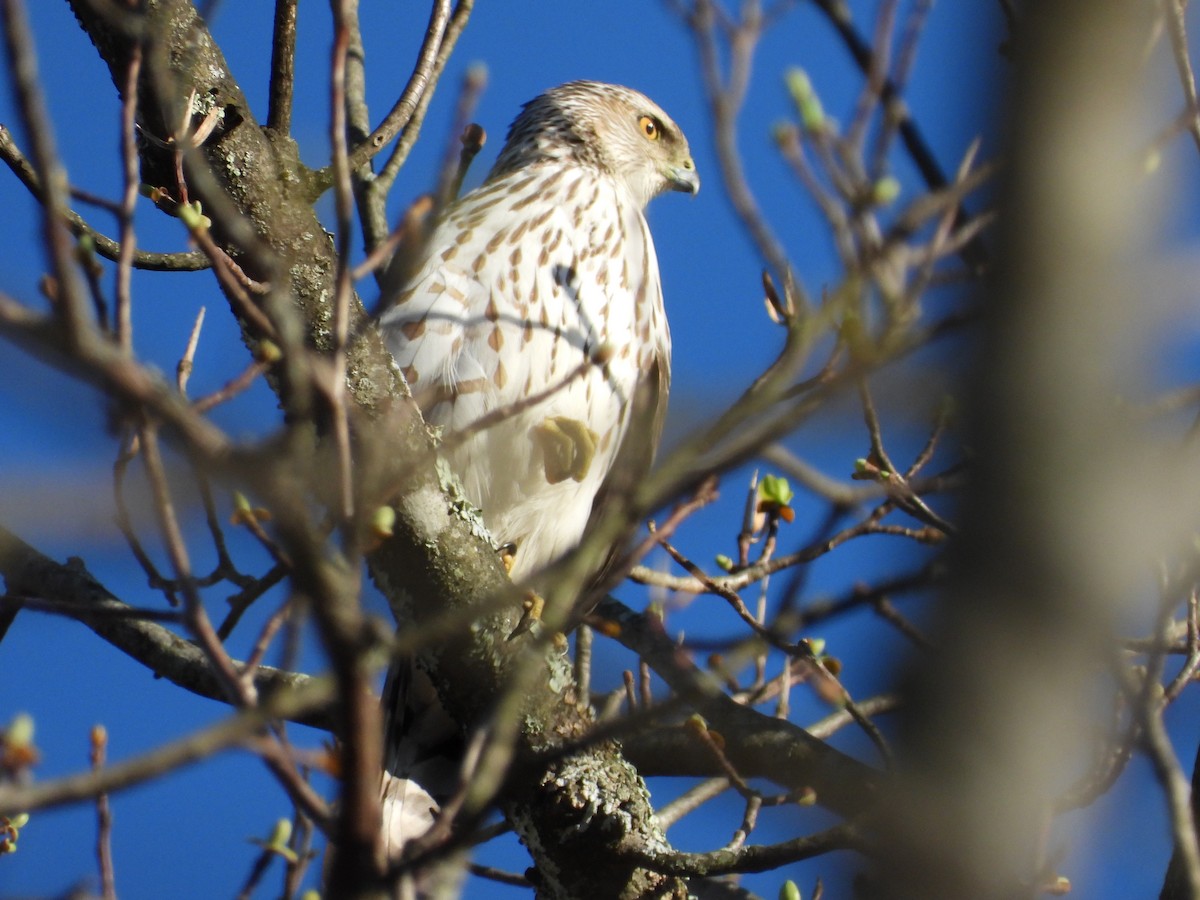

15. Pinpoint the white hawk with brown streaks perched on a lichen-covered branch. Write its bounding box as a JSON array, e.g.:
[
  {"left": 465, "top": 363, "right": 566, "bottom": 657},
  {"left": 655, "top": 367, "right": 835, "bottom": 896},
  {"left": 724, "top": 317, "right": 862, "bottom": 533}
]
[{"left": 382, "top": 82, "right": 700, "bottom": 847}]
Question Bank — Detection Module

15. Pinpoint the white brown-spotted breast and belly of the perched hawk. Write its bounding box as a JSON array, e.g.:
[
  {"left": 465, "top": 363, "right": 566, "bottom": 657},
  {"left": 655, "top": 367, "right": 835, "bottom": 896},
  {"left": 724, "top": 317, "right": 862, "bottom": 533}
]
[{"left": 382, "top": 163, "right": 671, "bottom": 578}]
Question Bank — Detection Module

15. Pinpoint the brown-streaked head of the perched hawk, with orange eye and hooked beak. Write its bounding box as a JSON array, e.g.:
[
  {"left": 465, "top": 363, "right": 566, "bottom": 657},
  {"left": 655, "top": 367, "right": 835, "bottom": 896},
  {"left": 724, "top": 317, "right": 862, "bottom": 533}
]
[{"left": 492, "top": 82, "right": 700, "bottom": 206}]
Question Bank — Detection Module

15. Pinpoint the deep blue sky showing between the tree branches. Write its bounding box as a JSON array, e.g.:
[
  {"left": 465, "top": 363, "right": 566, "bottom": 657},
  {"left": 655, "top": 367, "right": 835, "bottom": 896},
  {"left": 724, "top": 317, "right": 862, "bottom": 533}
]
[{"left": 0, "top": 0, "right": 1196, "bottom": 899}]
